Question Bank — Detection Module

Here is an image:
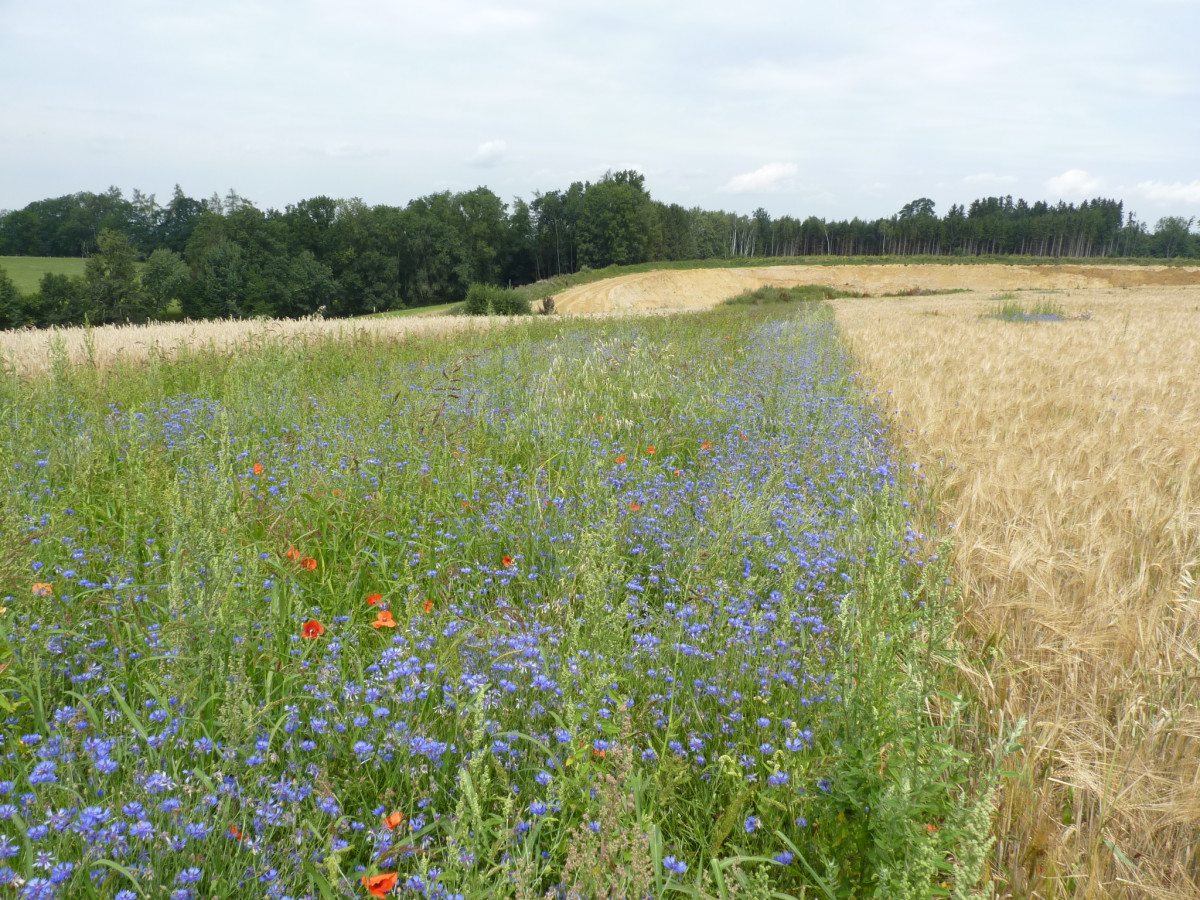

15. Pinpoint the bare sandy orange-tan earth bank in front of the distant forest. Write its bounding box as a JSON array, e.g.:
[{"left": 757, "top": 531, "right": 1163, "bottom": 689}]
[{"left": 554, "top": 264, "right": 1200, "bottom": 313}]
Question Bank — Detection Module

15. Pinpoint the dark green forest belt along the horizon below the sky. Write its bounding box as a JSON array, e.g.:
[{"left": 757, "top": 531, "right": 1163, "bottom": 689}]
[{"left": 0, "top": 170, "right": 1200, "bottom": 328}]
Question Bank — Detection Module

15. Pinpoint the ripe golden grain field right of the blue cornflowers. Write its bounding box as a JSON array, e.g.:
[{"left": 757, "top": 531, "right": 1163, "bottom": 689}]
[{"left": 835, "top": 287, "right": 1200, "bottom": 898}]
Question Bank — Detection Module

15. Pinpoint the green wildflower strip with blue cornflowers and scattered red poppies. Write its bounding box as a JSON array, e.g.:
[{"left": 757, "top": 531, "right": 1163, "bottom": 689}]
[{"left": 0, "top": 302, "right": 1000, "bottom": 900}]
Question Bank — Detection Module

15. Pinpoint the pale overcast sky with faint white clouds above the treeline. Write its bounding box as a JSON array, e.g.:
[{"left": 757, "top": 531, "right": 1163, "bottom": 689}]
[{"left": 0, "top": 0, "right": 1200, "bottom": 223}]
